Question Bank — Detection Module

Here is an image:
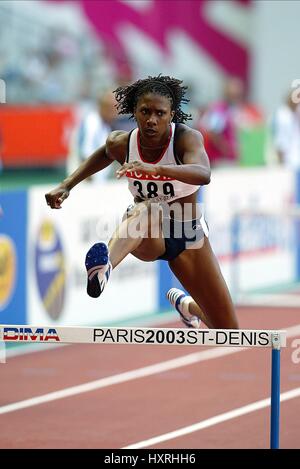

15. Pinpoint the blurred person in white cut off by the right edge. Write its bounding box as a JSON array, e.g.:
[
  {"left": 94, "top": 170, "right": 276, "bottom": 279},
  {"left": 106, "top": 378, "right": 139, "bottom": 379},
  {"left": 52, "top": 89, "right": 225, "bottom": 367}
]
[{"left": 272, "top": 92, "right": 300, "bottom": 169}]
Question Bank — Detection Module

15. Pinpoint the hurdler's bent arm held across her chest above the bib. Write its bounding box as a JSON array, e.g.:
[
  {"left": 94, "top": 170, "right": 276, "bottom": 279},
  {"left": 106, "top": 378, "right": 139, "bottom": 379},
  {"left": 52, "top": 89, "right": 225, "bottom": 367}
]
[{"left": 156, "top": 126, "right": 211, "bottom": 186}]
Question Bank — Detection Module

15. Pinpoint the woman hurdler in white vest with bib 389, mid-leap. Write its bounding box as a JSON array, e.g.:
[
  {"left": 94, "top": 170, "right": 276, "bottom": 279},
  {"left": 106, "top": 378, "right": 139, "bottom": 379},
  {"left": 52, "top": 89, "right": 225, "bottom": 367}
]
[{"left": 45, "top": 75, "right": 238, "bottom": 329}]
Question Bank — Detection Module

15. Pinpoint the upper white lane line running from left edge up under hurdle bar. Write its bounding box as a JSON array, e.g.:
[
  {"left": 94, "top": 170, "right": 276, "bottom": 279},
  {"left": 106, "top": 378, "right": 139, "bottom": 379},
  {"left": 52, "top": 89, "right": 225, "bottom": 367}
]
[{"left": 0, "top": 325, "right": 300, "bottom": 415}]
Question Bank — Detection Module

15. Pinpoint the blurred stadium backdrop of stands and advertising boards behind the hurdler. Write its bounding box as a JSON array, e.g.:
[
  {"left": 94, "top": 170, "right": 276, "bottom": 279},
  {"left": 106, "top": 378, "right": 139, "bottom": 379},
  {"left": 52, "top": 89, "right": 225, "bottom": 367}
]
[{"left": 0, "top": 0, "right": 300, "bottom": 325}]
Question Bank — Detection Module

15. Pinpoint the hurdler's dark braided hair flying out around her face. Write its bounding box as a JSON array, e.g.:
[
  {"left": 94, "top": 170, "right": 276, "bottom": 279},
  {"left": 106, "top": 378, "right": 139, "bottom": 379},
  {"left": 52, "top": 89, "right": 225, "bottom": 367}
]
[{"left": 114, "top": 75, "right": 191, "bottom": 123}]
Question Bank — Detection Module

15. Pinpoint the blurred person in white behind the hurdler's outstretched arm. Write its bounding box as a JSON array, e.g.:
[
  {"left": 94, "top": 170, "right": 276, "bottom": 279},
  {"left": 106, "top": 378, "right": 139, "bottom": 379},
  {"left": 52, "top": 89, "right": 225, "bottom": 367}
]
[{"left": 68, "top": 90, "right": 117, "bottom": 181}]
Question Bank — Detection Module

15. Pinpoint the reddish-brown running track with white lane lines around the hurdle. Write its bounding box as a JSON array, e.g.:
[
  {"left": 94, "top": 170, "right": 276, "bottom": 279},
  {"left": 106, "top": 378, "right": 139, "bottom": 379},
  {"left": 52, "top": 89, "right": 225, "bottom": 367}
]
[{"left": 0, "top": 308, "right": 300, "bottom": 449}]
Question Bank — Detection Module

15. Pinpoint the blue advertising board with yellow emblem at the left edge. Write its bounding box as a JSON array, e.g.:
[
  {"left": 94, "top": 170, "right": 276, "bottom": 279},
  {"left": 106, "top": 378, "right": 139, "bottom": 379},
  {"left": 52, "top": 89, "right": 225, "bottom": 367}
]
[{"left": 0, "top": 191, "right": 27, "bottom": 324}]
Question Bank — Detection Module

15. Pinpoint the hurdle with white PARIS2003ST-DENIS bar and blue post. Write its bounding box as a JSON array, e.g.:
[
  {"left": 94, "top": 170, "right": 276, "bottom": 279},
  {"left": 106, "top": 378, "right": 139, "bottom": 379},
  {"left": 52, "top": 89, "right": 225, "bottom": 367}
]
[{"left": 0, "top": 324, "right": 287, "bottom": 449}]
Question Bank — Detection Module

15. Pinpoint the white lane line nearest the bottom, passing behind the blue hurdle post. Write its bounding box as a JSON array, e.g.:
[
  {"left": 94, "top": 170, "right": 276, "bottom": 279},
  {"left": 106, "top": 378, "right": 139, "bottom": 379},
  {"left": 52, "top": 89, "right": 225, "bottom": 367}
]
[{"left": 122, "top": 388, "right": 300, "bottom": 449}]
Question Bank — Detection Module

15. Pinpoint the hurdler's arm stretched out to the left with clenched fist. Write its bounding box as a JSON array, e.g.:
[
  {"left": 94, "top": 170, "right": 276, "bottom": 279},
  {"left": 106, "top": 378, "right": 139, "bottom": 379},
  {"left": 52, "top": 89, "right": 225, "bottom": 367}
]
[{"left": 45, "top": 131, "right": 128, "bottom": 208}]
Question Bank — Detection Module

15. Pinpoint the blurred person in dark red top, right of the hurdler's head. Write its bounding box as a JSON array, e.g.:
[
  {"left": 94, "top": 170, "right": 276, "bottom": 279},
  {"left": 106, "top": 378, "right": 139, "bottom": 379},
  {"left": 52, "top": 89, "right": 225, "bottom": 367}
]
[{"left": 198, "top": 77, "right": 262, "bottom": 166}]
